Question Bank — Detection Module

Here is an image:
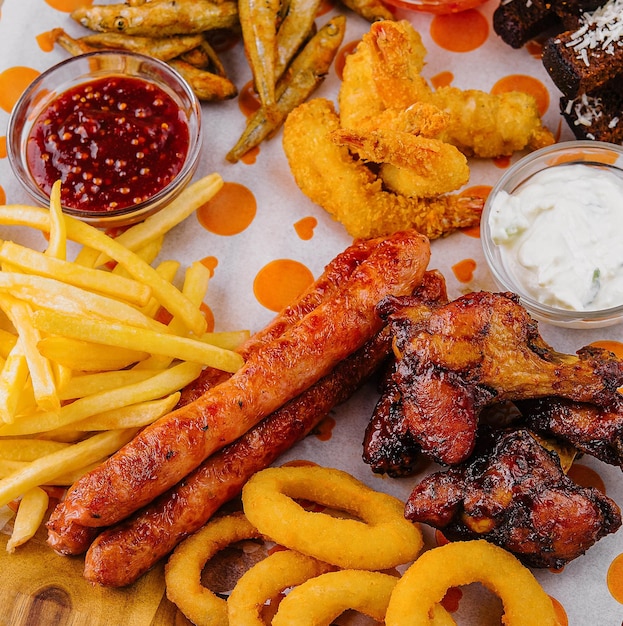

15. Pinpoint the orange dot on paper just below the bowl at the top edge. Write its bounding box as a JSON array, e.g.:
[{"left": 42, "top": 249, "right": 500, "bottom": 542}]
[{"left": 430, "top": 9, "right": 489, "bottom": 52}]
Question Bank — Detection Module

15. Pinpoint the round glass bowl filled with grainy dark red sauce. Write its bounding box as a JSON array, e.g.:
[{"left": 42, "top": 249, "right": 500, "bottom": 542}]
[{"left": 7, "top": 51, "right": 201, "bottom": 227}]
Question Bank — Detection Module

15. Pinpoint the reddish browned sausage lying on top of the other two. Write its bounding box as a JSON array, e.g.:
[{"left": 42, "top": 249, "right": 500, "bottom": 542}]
[{"left": 56, "top": 231, "right": 430, "bottom": 526}]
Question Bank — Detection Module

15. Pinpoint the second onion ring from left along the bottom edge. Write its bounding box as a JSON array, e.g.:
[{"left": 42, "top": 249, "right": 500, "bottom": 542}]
[{"left": 227, "top": 550, "right": 333, "bottom": 626}]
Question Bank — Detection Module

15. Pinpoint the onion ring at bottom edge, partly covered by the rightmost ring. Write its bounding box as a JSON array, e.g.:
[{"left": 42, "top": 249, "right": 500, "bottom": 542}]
[{"left": 272, "top": 570, "right": 398, "bottom": 626}]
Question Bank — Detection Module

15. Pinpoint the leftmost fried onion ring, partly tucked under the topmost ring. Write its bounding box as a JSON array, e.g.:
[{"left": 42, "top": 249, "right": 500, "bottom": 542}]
[{"left": 164, "top": 513, "right": 262, "bottom": 626}]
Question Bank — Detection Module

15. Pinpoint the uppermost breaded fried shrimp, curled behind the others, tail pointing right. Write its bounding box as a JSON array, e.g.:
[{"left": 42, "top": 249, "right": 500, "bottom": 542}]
[{"left": 339, "top": 21, "right": 554, "bottom": 158}]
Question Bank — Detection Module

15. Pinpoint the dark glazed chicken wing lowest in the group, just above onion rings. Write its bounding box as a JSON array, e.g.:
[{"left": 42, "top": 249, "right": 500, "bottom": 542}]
[{"left": 405, "top": 430, "right": 621, "bottom": 568}]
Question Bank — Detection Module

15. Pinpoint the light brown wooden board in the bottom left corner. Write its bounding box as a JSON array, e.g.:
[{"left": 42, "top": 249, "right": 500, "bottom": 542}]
[{"left": 0, "top": 516, "right": 190, "bottom": 626}]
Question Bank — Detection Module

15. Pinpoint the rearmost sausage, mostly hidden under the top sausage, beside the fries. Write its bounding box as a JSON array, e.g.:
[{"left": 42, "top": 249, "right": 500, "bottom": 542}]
[{"left": 47, "top": 239, "right": 376, "bottom": 555}]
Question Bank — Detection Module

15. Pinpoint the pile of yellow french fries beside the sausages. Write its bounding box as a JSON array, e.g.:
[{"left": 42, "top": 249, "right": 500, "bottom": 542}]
[{"left": 0, "top": 174, "right": 249, "bottom": 552}]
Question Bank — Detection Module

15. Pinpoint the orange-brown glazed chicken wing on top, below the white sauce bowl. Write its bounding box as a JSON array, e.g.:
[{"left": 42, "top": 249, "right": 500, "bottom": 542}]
[{"left": 373, "top": 292, "right": 623, "bottom": 465}]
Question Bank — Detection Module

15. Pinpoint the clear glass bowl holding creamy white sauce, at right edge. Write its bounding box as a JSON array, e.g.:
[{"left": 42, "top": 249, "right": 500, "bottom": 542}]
[{"left": 480, "top": 140, "right": 623, "bottom": 328}]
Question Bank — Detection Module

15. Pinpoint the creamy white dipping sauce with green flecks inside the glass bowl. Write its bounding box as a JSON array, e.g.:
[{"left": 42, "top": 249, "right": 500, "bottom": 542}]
[{"left": 489, "top": 164, "right": 623, "bottom": 311}]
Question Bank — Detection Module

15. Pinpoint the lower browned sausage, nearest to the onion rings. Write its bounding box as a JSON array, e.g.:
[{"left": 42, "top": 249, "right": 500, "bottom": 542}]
[{"left": 84, "top": 329, "right": 391, "bottom": 587}]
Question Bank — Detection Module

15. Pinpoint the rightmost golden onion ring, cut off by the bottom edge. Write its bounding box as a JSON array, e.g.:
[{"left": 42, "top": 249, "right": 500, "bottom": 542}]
[{"left": 385, "top": 539, "right": 558, "bottom": 626}]
